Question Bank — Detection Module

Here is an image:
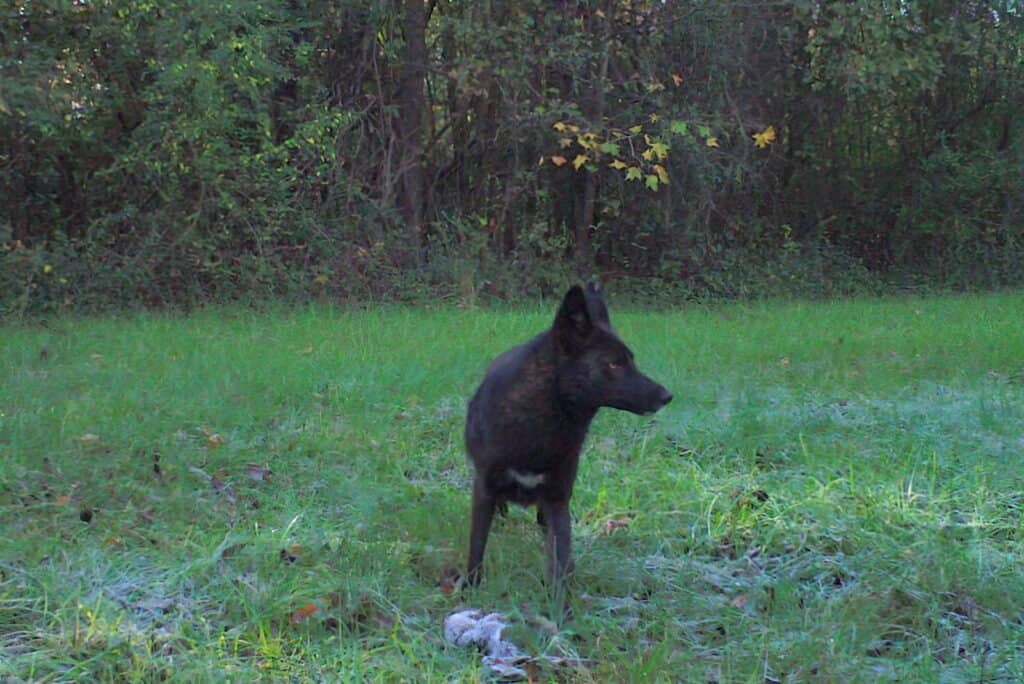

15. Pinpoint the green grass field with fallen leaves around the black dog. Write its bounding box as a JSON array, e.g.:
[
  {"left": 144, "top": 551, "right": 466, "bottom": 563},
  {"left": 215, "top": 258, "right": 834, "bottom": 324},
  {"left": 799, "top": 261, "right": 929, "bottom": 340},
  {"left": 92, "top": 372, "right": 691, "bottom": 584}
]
[{"left": 0, "top": 294, "right": 1024, "bottom": 682}]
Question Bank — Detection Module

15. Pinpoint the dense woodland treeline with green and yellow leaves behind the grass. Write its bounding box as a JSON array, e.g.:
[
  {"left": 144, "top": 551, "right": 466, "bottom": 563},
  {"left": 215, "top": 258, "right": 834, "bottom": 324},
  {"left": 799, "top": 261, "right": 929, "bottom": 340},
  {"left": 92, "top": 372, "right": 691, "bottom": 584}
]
[{"left": 0, "top": 0, "right": 1024, "bottom": 311}]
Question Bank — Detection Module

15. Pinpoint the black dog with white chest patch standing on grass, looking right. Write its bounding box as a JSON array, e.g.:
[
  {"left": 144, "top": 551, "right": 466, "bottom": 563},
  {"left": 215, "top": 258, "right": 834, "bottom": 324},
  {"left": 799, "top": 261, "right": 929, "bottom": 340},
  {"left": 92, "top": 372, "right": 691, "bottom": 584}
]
[{"left": 466, "top": 283, "right": 672, "bottom": 585}]
